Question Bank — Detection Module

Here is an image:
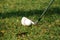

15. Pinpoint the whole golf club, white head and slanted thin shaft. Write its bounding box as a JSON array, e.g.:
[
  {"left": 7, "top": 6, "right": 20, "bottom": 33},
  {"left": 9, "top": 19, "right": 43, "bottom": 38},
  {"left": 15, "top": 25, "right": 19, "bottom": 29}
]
[{"left": 21, "top": 0, "right": 54, "bottom": 26}]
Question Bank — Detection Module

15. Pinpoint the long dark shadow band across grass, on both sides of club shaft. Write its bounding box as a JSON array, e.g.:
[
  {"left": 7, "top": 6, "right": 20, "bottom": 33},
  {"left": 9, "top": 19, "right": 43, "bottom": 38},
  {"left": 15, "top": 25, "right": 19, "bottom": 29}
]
[{"left": 0, "top": 7, "right": 60, "bottom": 19}]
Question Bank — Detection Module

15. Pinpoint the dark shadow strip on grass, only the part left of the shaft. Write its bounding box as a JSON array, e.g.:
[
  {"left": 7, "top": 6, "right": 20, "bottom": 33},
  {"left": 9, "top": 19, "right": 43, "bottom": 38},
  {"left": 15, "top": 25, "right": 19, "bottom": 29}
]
[{"left": 0, "top": 10, "right": 43, "bottom": 19}]
